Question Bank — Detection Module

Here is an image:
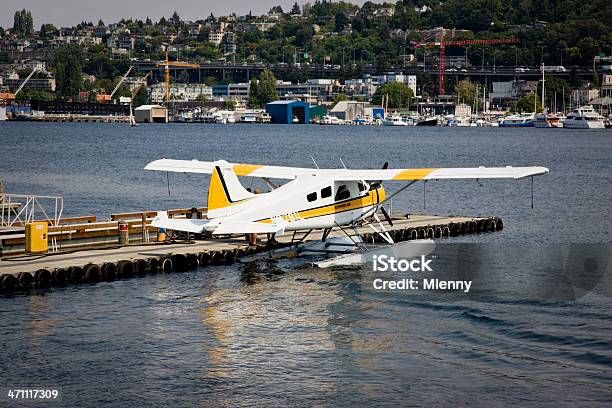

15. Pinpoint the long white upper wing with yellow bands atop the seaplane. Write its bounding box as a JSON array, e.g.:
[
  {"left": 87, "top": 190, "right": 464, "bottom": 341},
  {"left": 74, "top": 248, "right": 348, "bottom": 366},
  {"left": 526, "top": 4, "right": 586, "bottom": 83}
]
[{"left": 145, "top": 159, "right": 548, "bottom": 181}]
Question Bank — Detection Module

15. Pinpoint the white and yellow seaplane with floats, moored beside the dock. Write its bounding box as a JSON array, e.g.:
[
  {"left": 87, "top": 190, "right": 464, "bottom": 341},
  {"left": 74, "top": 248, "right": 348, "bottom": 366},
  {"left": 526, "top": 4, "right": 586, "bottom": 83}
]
[{"left": 145, "top": 159, "right": 548, "bottom": 267}]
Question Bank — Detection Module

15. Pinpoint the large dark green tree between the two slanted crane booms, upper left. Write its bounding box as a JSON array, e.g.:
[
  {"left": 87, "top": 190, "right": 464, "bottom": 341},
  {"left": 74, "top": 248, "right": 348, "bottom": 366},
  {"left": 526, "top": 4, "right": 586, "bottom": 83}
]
[{"left": 55, "top": 45, "right": 83, "bottom": 97}]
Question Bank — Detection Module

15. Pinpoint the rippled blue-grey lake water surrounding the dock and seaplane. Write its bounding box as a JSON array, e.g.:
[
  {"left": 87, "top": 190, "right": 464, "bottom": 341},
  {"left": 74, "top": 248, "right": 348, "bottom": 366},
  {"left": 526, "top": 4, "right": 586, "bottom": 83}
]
[{"left": 0, "top": 122, "right": 612, "bottom": 407}]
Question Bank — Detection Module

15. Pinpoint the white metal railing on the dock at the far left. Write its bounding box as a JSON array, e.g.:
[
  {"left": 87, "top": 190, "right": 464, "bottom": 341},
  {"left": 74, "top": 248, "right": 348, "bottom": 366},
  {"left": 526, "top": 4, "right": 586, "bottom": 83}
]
[{"left": 0, "top": 193, "right": 64, "bottom": 227}]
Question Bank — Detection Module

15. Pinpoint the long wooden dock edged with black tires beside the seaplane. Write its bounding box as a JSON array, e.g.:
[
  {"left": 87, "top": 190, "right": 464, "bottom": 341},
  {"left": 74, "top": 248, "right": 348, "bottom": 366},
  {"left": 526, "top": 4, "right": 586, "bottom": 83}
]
[{"left": 0, "top": 212, "right": 503, "bottom": 292}]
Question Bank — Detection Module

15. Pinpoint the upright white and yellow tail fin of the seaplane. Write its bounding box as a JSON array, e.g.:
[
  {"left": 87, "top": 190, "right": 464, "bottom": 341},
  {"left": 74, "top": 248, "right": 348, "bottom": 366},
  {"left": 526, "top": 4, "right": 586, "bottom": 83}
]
[{"left": 208, "top": 160, "right": 254, "bottom": 218}]
